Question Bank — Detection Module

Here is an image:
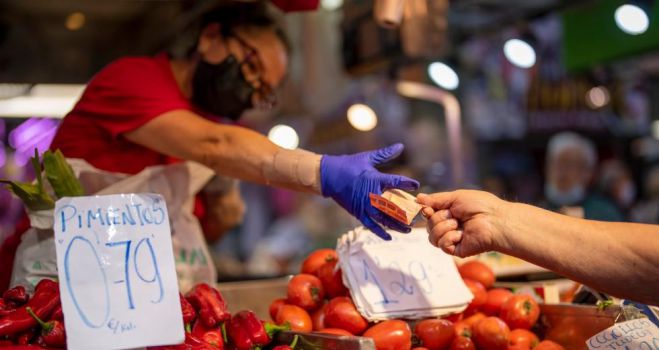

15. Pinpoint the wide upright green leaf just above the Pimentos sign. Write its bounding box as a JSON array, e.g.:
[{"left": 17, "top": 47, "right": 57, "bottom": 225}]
[{"left": 43, "top": 150, "right": 85, "bottom": 198}]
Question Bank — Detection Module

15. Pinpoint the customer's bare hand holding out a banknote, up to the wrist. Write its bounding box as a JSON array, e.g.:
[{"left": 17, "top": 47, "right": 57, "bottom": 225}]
[{"left": 417, "top": 190, "right": 507, "bottom": 257}]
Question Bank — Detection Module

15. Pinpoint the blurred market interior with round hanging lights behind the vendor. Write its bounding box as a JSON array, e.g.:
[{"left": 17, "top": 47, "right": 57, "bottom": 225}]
[{"left": 0, "top": 0, "right": 659, "bottom": 280}]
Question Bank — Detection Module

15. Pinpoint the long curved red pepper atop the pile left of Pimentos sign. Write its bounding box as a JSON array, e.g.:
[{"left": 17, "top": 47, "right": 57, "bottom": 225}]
[{"left": 0, "top": 280, "right": 60, "bottom": 337}]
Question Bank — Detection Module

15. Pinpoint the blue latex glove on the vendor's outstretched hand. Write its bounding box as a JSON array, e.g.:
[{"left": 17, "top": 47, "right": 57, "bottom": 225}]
[{"left": 320, "top": 143, "right": 419, "bottom": 240}]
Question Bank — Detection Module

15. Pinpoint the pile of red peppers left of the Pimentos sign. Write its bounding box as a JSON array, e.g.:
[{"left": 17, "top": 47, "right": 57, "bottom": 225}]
[{"left": 0, "top": 279, "right": 66, "bottom": 350}]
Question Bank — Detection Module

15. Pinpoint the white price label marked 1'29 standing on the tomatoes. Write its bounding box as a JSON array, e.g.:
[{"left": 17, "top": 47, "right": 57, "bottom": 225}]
[{"left": 337, "top": 229, "right": 472, "bottom": 321}]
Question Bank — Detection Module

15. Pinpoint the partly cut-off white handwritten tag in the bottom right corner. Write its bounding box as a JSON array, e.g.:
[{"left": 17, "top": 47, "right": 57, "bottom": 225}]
[{"left": 586, "top": 318, "right": 659, "bottom": 350}]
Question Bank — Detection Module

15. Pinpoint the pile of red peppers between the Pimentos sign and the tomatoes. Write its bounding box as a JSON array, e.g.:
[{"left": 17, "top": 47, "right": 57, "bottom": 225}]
[{"left": 149, "top": 283, "right": 292, "bottom": 350}]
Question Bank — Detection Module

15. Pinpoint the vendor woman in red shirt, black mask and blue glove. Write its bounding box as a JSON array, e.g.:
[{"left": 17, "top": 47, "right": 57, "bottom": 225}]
[{"left": 1, "top": 2, "right": 418, "bottom": 292}]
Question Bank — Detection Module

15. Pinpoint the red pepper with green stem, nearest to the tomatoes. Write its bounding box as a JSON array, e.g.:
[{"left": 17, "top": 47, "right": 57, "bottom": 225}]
[{"left": 226, "top": 310, "right": 289, "bottom": 350}]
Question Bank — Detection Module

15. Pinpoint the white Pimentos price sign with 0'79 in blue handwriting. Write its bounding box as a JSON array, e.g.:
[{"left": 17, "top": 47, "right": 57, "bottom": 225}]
[{"left": 54, "top": 194, "right": 185, "bottom": 350}]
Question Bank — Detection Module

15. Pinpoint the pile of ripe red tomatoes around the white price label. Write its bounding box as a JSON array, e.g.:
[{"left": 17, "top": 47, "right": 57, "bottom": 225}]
[{"left": 269, "top": 249, "right": 563, "bottom": 350}]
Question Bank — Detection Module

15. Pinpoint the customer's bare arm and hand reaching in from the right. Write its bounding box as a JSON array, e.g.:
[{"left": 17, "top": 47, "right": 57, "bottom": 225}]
[{"left": 418, "top": 190, "right": 659, "bottom": 304}]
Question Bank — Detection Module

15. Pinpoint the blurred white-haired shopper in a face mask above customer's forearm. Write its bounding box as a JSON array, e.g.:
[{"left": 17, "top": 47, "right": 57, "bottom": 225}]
[{"left": 540, "top": 132, "right": 623, "bottom": 221}]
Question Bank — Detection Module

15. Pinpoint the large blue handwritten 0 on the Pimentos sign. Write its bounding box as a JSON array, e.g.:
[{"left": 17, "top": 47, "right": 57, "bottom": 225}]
[{"left": 64, "top": 236, "right": 110, "bottom": 328}]
